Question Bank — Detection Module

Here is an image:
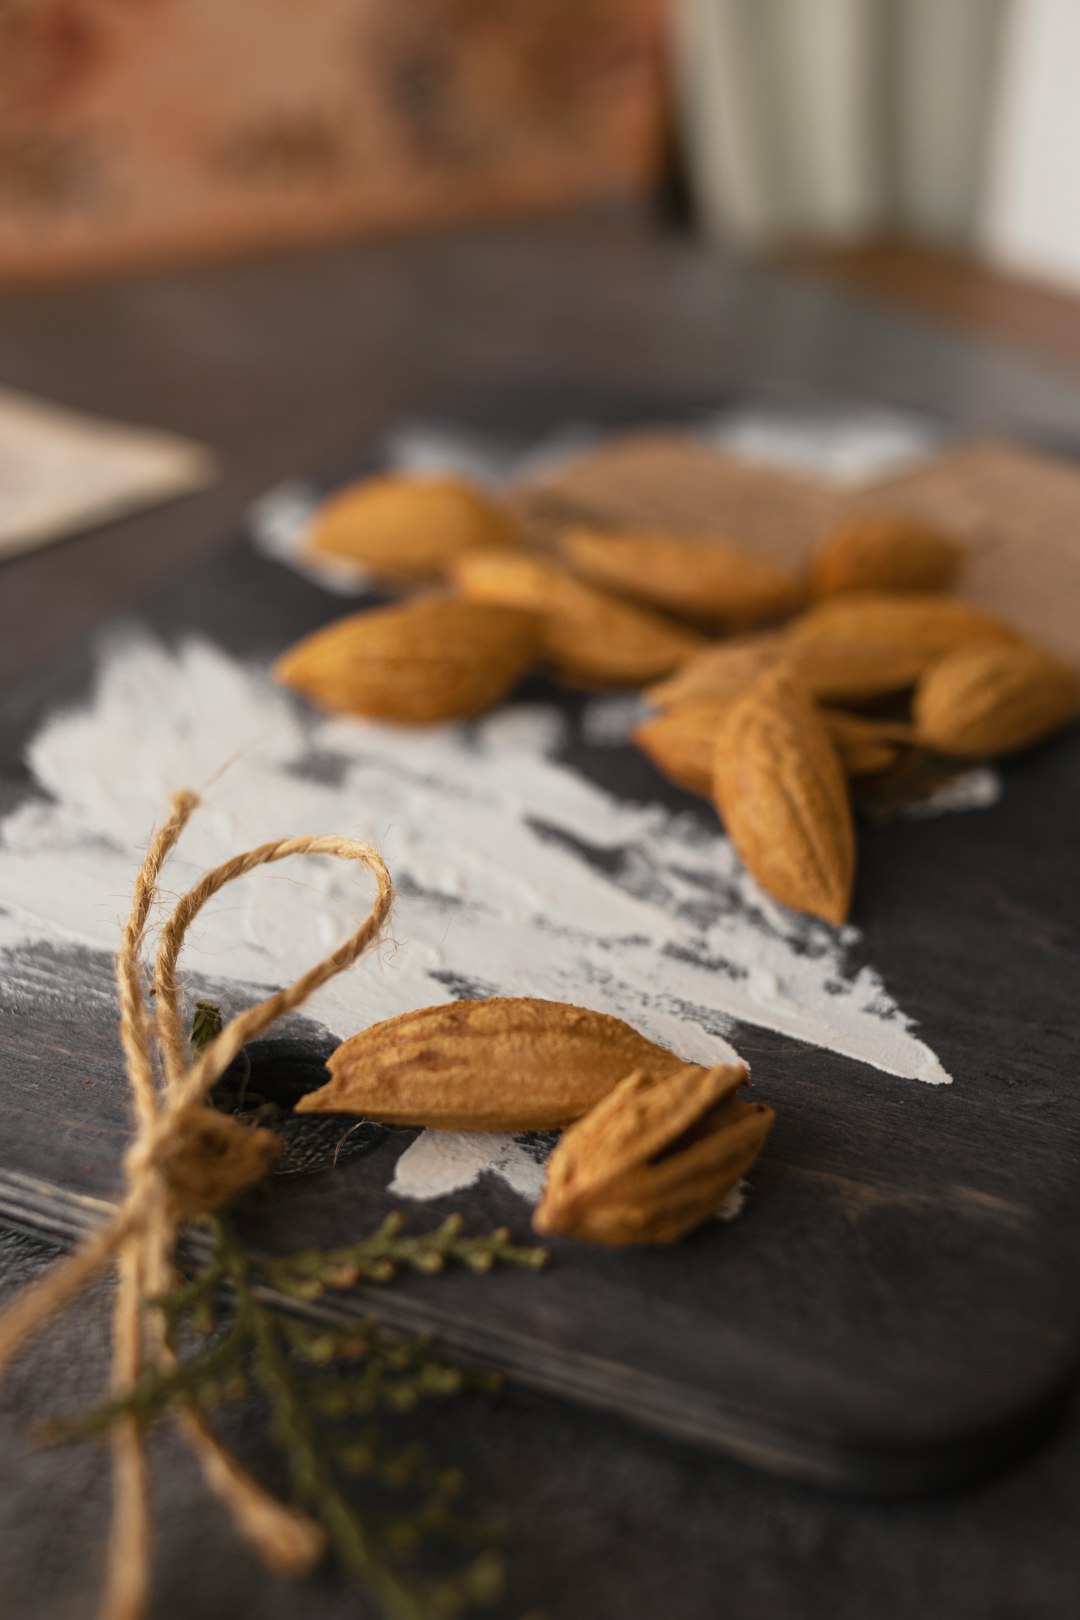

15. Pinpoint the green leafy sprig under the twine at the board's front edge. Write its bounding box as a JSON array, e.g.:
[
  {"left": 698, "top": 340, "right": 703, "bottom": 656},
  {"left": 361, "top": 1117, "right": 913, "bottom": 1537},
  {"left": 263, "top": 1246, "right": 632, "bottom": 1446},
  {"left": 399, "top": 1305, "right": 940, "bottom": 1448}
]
[{"left": 52, "top": 1217, "right": 546, "bottom": 1620}]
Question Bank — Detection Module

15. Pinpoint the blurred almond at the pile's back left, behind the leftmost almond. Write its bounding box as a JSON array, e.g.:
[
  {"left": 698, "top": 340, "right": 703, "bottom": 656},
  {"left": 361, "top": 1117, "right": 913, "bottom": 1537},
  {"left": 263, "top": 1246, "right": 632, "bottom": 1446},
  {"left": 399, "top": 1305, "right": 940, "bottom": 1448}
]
[{"left": 308, "top": 478, "right": 517, "bottom": 580}]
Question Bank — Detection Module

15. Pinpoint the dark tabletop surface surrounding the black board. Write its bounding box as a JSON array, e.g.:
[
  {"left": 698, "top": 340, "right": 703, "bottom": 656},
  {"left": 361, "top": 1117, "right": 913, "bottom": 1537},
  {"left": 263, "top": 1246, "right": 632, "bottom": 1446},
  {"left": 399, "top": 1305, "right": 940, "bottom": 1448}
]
[{"left": 0, "top": 214, "right": 1080, "bottom": 1620}]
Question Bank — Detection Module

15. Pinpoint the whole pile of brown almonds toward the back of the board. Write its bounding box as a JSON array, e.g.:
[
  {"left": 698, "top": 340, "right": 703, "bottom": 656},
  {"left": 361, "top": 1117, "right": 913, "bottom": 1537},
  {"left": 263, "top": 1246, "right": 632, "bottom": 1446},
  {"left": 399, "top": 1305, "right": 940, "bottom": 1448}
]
[{"left": 275, "top": 476, "right": 1080, "bottom": 925}]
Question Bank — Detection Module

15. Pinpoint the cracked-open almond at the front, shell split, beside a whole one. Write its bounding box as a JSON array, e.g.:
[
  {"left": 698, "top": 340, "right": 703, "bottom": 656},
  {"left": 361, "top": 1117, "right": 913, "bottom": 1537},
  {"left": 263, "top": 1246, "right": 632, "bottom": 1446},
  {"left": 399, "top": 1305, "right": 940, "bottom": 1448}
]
[{"left": 533, "top": 1063, "right": 774, "bottom": 1247}]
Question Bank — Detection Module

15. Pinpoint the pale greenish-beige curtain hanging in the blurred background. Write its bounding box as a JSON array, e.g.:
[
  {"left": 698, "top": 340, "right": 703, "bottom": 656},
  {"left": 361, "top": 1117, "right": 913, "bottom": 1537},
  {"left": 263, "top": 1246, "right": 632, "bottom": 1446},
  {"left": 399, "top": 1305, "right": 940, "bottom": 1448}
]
[{"left": 672, "top": 0, "right": 1016, "bottom": 245}]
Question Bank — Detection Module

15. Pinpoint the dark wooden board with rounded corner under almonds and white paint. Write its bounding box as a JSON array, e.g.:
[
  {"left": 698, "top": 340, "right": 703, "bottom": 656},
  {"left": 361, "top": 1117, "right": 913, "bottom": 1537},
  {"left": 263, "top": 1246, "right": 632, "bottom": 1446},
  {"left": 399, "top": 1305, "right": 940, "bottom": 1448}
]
[{"left": 0, "top": 390, "right": 1080, "bottom": 1494}]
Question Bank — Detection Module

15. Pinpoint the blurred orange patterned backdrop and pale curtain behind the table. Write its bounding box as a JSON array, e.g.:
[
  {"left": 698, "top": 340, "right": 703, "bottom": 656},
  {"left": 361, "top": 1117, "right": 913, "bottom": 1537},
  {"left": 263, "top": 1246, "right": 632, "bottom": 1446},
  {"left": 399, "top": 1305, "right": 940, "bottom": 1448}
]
[{"left": 0, "top": 0, "right": 1080, "bottom": 287}]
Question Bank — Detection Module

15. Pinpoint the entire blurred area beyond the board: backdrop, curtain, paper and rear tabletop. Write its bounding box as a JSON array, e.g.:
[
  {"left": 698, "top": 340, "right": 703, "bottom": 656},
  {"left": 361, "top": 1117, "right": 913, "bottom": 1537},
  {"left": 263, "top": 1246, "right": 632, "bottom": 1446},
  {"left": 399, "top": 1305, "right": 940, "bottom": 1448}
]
[{"left": 0, "top": 0, "right": 1080, "bottom": 682}]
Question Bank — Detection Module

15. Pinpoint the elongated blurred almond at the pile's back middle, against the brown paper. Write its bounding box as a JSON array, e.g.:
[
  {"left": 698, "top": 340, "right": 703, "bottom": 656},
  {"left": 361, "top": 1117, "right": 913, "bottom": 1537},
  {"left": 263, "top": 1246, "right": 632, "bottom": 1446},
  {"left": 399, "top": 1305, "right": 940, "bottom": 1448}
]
[{"left": 560, "top": 528, "right": 805, "bottom": 627}]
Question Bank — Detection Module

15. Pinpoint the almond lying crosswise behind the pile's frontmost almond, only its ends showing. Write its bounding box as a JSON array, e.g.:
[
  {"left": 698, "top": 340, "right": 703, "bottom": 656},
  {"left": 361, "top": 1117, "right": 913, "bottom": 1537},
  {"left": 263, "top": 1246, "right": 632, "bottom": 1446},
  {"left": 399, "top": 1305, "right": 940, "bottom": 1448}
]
[{"left": 633, "top": 703, "right": 915, "bottom": 795}]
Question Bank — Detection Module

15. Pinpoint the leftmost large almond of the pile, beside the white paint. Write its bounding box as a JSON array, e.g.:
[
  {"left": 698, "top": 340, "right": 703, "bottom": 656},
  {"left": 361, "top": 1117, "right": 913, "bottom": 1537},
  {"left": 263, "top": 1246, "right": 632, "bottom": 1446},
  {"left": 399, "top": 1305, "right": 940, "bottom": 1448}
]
[{"left": 274, "top": 598, "right": 539, "bottom": 726}]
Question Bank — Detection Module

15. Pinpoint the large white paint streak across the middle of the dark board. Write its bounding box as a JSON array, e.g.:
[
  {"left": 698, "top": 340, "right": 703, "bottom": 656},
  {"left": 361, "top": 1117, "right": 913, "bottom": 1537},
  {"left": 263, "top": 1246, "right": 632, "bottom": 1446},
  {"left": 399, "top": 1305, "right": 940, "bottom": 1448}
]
[{"left": 0, "top": 642, "right": 949, "bottom": 1196}]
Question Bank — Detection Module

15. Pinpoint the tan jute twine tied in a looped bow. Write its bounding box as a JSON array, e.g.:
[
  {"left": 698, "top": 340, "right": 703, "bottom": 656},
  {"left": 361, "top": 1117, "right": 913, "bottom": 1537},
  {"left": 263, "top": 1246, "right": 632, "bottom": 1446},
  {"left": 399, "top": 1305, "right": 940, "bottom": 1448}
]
[{"left": 0, "top": 792, "right": 393, "bottom": 1620}]
